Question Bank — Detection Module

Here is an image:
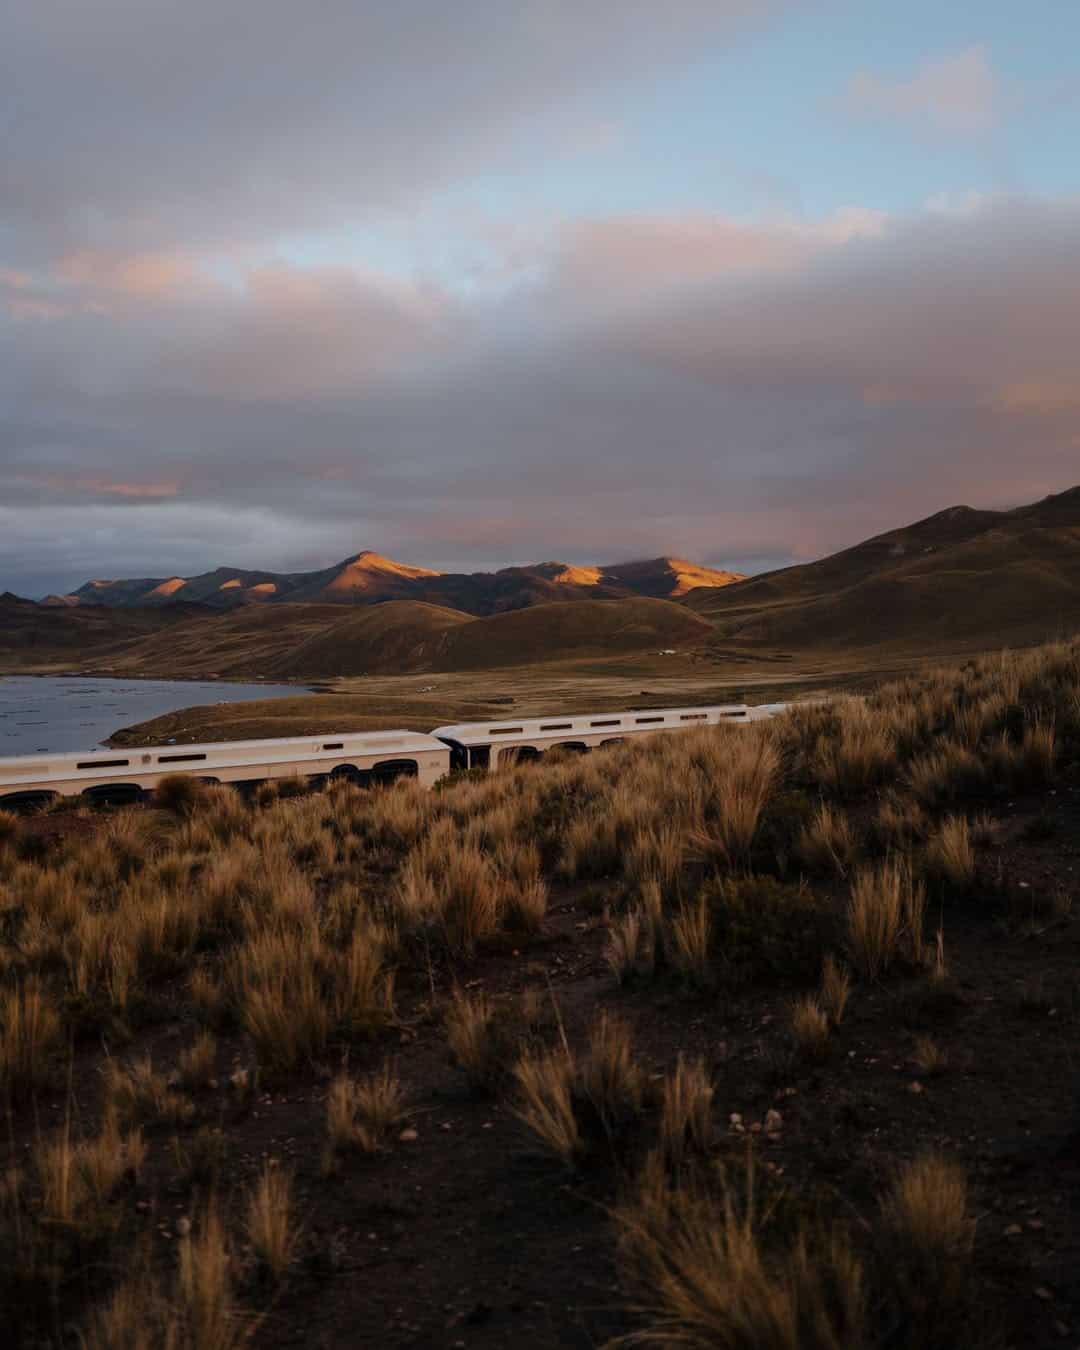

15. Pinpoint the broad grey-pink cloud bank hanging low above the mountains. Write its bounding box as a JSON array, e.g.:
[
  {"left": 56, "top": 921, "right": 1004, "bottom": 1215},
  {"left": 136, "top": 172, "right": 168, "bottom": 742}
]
[{"left": 0, "top": 198, "right": 1080, "bottom": 591}]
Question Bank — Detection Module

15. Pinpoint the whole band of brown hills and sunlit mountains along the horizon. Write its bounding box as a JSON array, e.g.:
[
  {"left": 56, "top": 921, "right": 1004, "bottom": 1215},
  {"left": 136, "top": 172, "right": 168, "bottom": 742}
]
[{"left": 8, "top": 487, "right": 1080, "bottom": 679}]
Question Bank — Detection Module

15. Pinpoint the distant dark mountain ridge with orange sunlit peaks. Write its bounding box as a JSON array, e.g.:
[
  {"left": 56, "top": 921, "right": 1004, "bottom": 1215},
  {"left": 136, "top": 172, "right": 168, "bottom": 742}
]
[{"left": 57, "top": 549, "right": 740, "bottom": 616}]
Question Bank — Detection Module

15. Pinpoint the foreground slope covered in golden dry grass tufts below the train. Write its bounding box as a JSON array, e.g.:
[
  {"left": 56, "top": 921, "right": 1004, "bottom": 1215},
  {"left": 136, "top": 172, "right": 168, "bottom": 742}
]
[{"left": 0, "top": 643, "right": 1080, "bottom": 1350}]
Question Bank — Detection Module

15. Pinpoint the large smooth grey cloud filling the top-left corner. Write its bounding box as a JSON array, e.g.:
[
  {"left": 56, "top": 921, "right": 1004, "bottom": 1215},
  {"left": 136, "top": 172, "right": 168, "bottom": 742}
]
[{"left": 0, "top": 0, "right": 777, "bottom": 259}]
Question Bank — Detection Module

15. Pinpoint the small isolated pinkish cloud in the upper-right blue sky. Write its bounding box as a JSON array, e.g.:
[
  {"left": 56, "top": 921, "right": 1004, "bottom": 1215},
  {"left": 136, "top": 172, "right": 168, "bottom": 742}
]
[{"left": 844, "top": 46, "right": 1003, "bottom": 136}]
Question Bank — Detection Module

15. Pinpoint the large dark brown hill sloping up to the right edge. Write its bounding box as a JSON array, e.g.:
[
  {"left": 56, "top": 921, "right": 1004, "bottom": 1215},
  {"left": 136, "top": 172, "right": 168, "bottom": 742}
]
[{"left": 686, "top": 487, "right": 1080, "bottom": 648}]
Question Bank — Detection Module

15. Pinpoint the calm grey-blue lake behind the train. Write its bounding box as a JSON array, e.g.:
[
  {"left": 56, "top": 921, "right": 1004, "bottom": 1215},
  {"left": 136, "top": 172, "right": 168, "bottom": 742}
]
[{"left": 0, "top": 675, "right": 304, "bottom": 756}]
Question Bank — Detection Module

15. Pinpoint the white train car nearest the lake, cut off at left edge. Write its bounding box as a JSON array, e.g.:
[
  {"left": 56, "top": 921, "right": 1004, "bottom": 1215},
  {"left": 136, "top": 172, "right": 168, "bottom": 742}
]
[{"left": 0, "top": 730, "right": 450, "bottom": 807}]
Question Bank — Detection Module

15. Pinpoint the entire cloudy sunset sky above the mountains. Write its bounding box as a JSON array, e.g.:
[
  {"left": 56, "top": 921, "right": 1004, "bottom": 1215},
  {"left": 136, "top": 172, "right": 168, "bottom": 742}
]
[{"left": 0, "top": 0, "right": 1080, "bottom": 597}]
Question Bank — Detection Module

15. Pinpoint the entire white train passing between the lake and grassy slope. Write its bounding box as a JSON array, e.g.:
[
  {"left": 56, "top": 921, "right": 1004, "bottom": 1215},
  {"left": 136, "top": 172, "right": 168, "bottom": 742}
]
[{"left": 0, "top": 703, "right": 786, "bottom": 809}]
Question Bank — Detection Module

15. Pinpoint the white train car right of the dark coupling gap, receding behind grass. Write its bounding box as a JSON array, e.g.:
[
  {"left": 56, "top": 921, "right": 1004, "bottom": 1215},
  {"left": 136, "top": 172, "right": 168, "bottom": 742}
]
[{"left": 432, "top": 703, "right": 761, "bottom": 770}]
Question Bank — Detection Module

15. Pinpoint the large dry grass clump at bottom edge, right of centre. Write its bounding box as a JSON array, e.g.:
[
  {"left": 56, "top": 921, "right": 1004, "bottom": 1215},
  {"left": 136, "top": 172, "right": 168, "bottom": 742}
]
[{"left": 616, "top": 1154, "right": 973, "bottom": 1350}]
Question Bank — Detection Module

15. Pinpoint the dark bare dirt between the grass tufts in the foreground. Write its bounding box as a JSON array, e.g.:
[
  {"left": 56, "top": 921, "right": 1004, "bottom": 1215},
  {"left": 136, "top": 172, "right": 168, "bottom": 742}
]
[{"left": 8, "top": 787, "right": 1080, "bottom": 1350}]
